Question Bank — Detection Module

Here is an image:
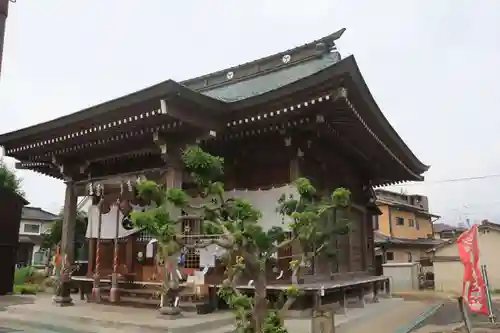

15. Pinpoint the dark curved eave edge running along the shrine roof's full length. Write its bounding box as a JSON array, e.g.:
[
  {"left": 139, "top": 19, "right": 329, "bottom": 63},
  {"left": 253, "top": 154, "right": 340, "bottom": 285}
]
[{"left": 0, "top": 52, "right": 429, "bottom": 181}]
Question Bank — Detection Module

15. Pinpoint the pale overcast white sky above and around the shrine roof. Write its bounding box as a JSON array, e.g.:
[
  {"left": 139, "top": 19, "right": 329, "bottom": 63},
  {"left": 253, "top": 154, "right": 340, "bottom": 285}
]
[{"left": 0, "top": 0, "right": 500, "bottom": 224}]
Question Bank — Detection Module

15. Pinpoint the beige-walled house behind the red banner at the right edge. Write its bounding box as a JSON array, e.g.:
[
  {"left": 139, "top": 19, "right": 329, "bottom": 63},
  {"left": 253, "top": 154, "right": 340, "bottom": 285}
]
[{"left": 429, "top": 221, "right": 500, "bottom": 293}]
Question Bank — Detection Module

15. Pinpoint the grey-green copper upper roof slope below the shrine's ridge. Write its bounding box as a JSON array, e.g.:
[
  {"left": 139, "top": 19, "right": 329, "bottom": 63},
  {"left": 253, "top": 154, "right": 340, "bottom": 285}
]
[{"left": 201, "top": 52, "right": 341, "bottom": 102}]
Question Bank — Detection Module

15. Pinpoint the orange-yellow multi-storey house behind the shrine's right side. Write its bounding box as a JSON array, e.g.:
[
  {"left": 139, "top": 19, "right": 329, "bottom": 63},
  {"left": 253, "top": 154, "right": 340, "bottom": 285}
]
[{"left": 374, "top": 189, "right": 441, "bottom": 264}]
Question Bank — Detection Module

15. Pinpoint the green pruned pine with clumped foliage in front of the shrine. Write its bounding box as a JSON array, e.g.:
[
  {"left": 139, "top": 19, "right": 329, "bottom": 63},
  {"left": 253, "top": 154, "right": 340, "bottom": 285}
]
[{"left": 132, "top": 147, "right": 350, "bottom": 333}]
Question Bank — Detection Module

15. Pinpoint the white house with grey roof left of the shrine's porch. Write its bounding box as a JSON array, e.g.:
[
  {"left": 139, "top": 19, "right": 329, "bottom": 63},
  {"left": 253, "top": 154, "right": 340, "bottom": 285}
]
[{"left": 17, "top": 207, "right": 57, "bottom": 266}]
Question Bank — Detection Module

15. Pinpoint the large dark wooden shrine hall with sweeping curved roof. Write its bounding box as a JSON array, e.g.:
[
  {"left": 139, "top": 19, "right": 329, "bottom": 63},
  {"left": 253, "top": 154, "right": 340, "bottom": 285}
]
[{"left": 0, "top": 29, "right": 429, "bottom": 308}]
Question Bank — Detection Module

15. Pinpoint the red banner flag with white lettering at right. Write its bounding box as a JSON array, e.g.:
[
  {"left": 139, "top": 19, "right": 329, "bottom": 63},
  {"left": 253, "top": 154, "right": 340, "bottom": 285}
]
[{"left": 457, "top": 225, "right": 488, "bottom": 314}]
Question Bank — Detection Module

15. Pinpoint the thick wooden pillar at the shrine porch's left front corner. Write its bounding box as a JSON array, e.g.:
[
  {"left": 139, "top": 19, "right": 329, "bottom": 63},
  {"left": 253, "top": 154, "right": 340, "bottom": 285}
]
[{"left": 54, "top": 180, "right": 78, "bottom": 306}]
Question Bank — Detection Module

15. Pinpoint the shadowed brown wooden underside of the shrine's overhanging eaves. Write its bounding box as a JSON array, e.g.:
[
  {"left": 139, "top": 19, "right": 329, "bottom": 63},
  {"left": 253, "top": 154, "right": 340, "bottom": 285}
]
[{"left": 13, "top": 99, "right": 421, "bottom": 185}]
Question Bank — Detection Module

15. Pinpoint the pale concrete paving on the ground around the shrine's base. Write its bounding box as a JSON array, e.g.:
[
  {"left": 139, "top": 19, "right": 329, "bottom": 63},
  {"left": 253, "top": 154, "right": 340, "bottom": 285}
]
[{"left": 0, "top": 295, "right": 438, "bottom": 333}]
